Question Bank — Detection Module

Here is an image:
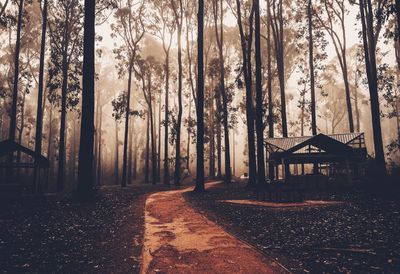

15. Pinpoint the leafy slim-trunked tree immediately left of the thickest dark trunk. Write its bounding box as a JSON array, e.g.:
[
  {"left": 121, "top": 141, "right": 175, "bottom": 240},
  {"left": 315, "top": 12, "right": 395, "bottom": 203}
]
[{"left": 48, "top": 0, "right": 83, "bottom": 191}]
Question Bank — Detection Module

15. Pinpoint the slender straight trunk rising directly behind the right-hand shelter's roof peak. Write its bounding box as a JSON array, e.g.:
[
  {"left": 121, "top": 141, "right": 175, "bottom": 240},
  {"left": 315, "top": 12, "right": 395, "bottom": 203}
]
[{"left": 307, "top": 0, "right": 317, "bottom": 135}]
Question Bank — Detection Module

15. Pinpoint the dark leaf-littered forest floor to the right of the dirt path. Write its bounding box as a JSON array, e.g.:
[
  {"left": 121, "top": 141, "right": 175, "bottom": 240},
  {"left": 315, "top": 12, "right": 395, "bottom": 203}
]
[{"left": 184, "top": 183, "right": 400, "bottom": 273}]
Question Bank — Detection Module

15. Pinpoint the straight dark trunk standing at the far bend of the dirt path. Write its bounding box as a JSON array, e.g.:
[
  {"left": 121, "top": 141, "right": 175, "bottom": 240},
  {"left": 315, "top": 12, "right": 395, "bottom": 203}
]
[{"left": 195, "top": 0, "right": 204, "bottom": 192}]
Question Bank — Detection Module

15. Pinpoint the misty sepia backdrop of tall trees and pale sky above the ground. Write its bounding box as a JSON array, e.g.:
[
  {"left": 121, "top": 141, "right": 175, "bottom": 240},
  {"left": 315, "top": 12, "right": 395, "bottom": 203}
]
[{"left": 0, "top": 0, "right": 400, "bottom": 195}]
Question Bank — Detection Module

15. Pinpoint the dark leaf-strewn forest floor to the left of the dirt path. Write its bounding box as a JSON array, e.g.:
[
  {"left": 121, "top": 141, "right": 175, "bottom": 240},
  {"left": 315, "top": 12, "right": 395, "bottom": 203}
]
[{"left": 0, "top": 182, "right": 177, "bottom": 273}]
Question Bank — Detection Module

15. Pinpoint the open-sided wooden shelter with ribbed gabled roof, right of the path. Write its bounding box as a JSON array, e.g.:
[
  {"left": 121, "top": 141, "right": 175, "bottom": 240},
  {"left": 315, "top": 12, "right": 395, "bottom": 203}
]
[{"left": 266, "top": 133, "right": 368, "bottom": 181}]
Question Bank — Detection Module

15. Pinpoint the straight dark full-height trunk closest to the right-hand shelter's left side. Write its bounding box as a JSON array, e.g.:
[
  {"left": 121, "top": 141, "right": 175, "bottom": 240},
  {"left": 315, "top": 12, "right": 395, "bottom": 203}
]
[{"left": 253, "top": 0, "right": 265, "bottom": 184}]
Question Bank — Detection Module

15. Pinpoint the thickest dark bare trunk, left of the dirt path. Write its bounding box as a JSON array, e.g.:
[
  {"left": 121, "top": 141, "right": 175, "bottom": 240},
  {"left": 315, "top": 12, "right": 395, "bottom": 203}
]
[{"left": 78, "top": 0, "right": 96, "bottom": 197}]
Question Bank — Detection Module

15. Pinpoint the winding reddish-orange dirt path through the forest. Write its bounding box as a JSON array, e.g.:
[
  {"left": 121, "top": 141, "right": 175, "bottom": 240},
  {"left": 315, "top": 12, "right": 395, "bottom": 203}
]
[{"left": 141, "top": 184, "right": 284, "bottom": 274}]
